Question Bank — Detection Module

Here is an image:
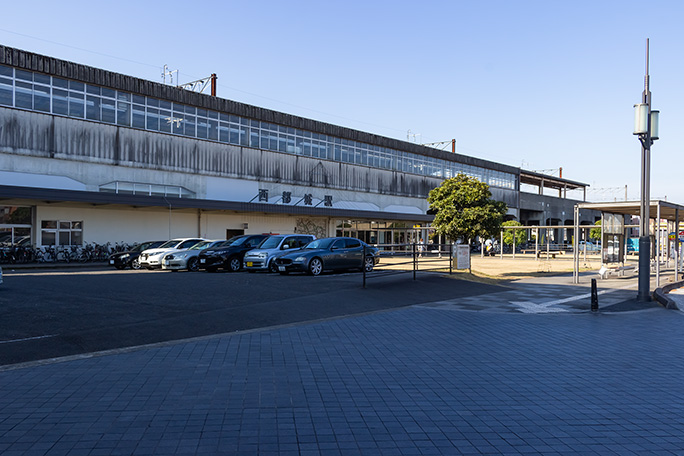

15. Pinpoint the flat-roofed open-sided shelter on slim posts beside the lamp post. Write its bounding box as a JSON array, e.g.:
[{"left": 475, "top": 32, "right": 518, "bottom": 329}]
[{"left": 573, "top": 200, "right": 684, "bottom": 287}]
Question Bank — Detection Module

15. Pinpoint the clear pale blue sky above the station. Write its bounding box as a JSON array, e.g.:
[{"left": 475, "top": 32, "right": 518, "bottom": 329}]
[{"left": 0, "top": 0, "right": 684, "bottom": 204}]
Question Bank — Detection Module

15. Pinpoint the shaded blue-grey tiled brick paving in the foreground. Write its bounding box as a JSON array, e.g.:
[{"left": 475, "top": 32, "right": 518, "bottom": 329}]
[{"left": 0, "top": 272, "right": 684, "bottom": 456}]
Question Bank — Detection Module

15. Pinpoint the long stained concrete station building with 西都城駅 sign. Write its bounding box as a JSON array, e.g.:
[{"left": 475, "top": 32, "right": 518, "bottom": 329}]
[{"left": 0, "top": 46, "right": 594, "bottom": 246}]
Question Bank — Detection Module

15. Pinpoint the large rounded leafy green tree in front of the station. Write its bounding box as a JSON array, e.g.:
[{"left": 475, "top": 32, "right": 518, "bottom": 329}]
[{"left": 428, "top": 173, "right": 507, "bottom": 243}]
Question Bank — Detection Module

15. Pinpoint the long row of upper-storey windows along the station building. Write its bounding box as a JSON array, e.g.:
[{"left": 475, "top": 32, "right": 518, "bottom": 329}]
[{"left": 0, "top": 65, "right": 516, "bottom": 189}]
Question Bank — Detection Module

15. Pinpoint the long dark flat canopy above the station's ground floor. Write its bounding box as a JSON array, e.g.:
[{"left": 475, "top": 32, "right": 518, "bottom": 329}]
[{"left": 0, "top": 185, "right": 434, "bottom": 222}]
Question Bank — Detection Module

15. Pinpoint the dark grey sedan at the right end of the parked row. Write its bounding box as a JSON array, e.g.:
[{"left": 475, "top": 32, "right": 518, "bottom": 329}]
[{"left": 275, "top": 237, "right": 380, "bottom": 275}]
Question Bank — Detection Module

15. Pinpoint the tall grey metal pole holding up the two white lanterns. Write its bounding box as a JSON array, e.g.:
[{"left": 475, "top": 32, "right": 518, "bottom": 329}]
[{"left": 637, "top": 38, "right": 652, "bottom": 301}]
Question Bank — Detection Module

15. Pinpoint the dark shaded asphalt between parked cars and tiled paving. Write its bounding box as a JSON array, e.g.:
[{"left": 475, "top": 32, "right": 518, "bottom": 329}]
[{"left": 0, "top": 269, "right": 499, "bottom": 366}]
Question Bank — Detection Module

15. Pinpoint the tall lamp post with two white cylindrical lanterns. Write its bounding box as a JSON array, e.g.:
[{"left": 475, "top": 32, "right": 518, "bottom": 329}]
[{"left": 634, "top": 39, "right": 660, "bottom": 302}]
